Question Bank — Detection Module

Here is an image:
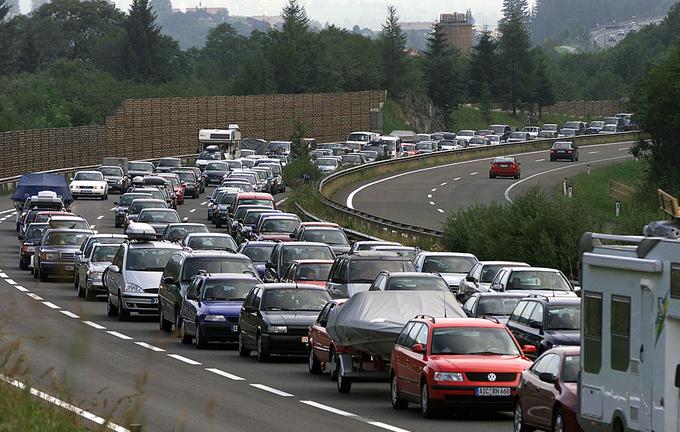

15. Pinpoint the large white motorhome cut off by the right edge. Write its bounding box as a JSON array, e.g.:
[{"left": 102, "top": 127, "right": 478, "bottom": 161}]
[{"left": 578, "top": 231, "right": 680, "bottom": 432}]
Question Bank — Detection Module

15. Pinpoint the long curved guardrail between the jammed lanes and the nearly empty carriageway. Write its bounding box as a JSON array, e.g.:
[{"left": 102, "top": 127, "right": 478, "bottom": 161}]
[{"left": 318, "top": 131, "right": 641, "bottom": 241}]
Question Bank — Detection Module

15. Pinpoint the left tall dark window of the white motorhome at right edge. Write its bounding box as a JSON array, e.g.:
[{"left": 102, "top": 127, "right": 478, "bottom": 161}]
[{"left": 582, "top": 292, "right": 602, "bottom": 373}]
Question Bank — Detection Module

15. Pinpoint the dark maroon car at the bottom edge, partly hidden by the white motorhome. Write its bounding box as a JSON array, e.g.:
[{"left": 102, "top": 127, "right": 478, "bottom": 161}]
[{"left": 514, "top": 346, "right": 583, "bottom": 432}]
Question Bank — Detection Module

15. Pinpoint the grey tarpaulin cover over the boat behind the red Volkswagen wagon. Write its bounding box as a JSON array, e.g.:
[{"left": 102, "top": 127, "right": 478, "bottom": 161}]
[{"left": 326, "top": 291, "right": 466, "bottom": 359}]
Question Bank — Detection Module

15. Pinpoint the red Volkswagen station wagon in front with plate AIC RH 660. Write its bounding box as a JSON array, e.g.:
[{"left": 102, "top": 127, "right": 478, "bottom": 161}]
[{"left": 390, "top": 317, "right": 536, "bottom": 418}]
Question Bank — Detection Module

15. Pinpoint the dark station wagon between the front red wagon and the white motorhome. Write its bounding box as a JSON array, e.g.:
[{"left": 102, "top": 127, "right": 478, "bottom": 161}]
[{"left": 506, "top": 294, "right": 581, "bottom": 357}]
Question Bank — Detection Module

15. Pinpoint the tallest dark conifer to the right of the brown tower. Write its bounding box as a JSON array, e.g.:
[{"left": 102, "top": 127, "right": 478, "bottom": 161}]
[{"left": 498, "top": 0, "right": 531, "bottom": 115}]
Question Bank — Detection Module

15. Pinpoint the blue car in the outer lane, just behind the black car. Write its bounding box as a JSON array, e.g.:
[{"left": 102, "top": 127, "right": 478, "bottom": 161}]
[{"left": 177, "top": 271, "right": 262, "bottom": 349}]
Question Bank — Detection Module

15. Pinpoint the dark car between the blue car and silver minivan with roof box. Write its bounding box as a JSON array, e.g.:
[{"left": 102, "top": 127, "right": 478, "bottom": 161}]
[{"left": 158, "top": 250, "right": 257, "bottom": 331}]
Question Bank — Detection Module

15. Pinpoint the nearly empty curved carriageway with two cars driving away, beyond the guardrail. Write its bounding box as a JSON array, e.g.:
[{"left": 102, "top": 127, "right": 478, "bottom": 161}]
[{"left": 333, "top": 142, "right": 632, "bottom": 230}]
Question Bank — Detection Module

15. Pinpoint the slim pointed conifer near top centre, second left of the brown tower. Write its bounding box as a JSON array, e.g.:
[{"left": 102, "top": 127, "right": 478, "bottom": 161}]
[{"left": 378, "top": 6, "right": 406, "bottom": 96}]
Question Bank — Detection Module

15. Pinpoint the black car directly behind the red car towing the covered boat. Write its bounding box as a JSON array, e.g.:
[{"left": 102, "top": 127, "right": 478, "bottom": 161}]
[{"left": 238, "top": 283, "right": 331, "bottom": 362}]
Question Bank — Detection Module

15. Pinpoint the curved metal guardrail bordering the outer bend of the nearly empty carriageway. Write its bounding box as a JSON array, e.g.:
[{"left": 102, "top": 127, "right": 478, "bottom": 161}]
[{"left": 317, "top": 131, "right": 640, "bottom": 240}]
